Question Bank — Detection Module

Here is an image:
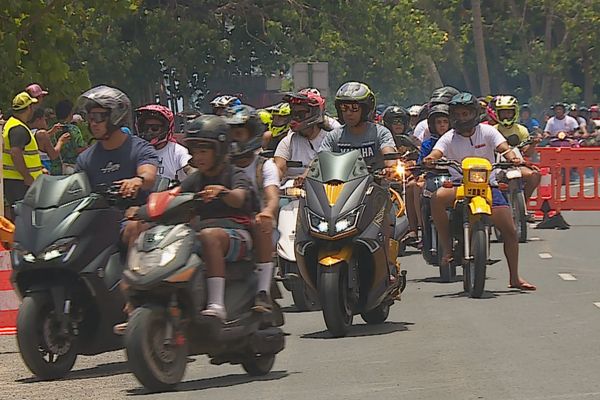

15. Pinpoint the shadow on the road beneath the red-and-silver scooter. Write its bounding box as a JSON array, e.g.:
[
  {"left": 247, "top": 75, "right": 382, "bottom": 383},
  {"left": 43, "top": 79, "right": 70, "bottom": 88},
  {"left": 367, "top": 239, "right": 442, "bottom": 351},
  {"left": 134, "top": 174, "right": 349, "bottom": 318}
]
[{"left": 127, "top": 371, "right": 290, "bottom": 396}]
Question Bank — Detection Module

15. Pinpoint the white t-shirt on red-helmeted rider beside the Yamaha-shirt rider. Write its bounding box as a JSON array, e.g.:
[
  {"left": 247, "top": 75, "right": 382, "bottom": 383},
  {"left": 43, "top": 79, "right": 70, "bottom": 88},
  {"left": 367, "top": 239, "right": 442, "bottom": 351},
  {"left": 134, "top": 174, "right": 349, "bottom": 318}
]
[{"left": 275, "top": 129, "right": 327, "bottom": 178}]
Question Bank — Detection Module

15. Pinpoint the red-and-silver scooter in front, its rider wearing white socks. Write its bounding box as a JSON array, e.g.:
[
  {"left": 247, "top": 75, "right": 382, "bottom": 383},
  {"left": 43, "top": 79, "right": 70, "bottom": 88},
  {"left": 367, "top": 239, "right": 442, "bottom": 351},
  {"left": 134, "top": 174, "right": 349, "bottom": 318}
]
[{"left": 123, "top": 188, "right": 285, "bottom": 391}]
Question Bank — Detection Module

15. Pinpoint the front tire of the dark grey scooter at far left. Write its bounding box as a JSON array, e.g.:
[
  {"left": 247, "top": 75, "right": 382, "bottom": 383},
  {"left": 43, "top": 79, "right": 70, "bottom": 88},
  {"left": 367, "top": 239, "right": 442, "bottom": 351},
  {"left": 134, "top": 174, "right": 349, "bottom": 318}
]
[{"left": 17, "top": 293, "right": 77, "bottom": 380}]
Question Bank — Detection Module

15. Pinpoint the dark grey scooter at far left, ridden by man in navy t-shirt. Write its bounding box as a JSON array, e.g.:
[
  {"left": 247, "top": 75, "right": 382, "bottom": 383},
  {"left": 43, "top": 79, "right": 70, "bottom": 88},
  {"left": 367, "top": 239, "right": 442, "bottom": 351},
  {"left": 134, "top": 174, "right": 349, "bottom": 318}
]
[{"left": 11, "top": 172, "right": 130, "bottom": 380}]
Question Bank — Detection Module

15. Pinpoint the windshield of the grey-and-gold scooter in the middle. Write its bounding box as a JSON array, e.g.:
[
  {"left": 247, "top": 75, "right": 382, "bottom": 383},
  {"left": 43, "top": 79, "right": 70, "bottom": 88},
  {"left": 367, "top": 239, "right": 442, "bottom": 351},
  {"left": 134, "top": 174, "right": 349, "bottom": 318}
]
[{"left": 308, "top": 150, "right": 369, "bottom": 183}]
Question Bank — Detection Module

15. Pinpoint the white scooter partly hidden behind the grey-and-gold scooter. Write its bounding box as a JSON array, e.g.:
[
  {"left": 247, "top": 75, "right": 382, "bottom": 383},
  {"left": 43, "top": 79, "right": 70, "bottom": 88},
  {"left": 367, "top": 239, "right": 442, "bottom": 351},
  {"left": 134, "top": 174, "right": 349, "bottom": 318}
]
[{"left": 277, "top": 179, "right": 321, "bottom": 311}]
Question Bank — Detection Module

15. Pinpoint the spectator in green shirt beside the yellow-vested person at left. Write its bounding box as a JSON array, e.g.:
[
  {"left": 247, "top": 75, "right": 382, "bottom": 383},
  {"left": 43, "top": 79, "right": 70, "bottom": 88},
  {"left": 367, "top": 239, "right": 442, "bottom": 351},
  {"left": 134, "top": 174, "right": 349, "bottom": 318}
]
[{"left": 52, "top": 100, "right": 86, "bottom": 175}]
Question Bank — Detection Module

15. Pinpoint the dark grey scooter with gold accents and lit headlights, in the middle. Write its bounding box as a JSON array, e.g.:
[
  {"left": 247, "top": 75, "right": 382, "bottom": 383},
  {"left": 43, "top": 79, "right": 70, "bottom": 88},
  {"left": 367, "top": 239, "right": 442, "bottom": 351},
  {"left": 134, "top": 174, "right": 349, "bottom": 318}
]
[{"left": 295, "top": 150, "right": 406, "bottom": 337}]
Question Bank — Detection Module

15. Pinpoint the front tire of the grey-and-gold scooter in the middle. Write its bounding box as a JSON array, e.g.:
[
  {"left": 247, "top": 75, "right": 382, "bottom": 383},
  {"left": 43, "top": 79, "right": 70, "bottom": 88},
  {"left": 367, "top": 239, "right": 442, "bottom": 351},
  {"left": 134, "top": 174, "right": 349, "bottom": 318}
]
[{"left": 319, "top": 268, "right": 354, "bottom": 337}]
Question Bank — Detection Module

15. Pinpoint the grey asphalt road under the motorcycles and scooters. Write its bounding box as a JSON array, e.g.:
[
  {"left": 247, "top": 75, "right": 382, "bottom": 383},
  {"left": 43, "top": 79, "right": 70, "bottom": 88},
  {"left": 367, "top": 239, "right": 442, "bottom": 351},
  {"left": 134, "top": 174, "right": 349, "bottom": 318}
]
[{"left": 0, "top": 212, "right": 600, "bottom": 400}]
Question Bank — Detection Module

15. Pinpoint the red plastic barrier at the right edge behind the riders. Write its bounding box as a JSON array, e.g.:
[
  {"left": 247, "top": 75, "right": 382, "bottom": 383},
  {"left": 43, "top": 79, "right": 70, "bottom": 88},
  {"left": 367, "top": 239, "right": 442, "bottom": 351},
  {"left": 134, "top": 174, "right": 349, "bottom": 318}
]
[{"left": 528, "top": 147, "right": 600, "bottom": 212}]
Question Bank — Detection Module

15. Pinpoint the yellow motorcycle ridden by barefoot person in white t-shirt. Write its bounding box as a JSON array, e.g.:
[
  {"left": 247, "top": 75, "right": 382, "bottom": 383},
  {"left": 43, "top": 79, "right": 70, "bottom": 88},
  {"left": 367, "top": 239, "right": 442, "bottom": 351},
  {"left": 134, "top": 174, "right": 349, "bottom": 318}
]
[{"left": 435, "top": 157, "right": 513, "bottom": 298}]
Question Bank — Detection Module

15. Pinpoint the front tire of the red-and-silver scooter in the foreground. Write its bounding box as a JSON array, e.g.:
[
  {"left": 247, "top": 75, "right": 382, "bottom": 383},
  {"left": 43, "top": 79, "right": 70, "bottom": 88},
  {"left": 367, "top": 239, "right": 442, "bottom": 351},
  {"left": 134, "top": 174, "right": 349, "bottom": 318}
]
[{"left": 125, "top": 305, "right": 187, "bottom": 392}]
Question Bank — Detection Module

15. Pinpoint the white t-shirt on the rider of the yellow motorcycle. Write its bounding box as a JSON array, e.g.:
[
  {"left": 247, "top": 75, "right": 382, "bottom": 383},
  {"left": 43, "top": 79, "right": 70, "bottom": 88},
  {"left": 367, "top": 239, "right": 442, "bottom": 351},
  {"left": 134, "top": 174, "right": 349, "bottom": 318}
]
[{"left": 433, "top": 124, "right": 506, "bottom": 178}]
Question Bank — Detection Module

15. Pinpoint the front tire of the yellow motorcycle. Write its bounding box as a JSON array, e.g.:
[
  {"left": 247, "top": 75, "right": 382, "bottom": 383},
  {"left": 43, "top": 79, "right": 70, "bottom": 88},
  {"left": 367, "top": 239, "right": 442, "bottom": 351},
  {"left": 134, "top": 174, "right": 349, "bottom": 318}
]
[{"left": 463, "top": 225, "right": 488, "bottom": 298}]
